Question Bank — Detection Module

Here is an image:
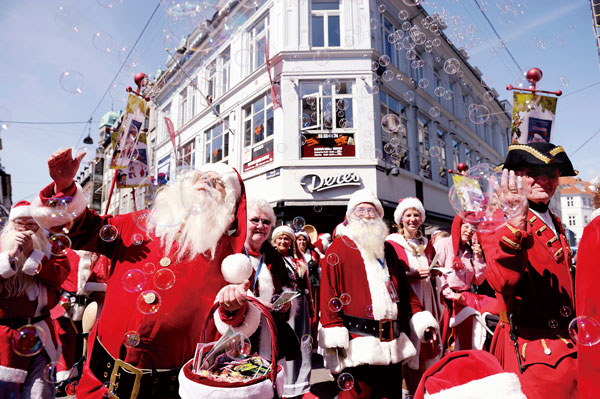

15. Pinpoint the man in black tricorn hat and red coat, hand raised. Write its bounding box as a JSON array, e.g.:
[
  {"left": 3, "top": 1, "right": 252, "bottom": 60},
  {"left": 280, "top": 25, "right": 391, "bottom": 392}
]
[{"left": 481, "top": 143, "right": 578, "bottom": 399}]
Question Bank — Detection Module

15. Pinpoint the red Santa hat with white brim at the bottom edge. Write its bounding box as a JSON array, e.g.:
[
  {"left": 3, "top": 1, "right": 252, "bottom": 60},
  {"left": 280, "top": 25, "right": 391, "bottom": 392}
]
[{"left": 414, "top": 350, "right": 527, "bottom": 399}]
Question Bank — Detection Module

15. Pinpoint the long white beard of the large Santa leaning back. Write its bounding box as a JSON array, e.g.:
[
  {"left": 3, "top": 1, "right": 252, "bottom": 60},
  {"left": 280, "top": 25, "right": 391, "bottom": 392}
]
[{"left": 148, "top": 174, "right": 236, "bottom": 260}]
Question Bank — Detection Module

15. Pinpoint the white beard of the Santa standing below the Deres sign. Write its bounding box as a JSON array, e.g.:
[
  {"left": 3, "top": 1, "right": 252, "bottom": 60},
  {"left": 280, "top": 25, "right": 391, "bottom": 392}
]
[{"left": 346, "top": 218, "right": 389, "bottom": 259}]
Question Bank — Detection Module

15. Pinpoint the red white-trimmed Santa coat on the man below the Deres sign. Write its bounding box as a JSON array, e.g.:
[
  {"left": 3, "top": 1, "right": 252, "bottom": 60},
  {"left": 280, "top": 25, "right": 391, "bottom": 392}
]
[{"left": 319, "top": 236, "right": 435, "bottom": 373}]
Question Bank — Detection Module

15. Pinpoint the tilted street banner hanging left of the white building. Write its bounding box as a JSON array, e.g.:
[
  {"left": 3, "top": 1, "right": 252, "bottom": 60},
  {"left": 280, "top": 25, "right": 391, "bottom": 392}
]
[{"left": 110, "top": 94, "right": 148, "bottom": 169}]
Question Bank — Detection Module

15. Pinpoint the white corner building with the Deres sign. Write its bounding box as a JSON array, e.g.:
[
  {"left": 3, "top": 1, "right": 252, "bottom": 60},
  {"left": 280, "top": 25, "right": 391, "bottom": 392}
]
[{"left": 149, "top": 0, "right": 510, "bottom": 231}]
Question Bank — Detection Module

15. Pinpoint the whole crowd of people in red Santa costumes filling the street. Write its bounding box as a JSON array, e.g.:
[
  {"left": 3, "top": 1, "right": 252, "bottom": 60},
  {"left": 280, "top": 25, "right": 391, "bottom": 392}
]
[{"left": 0, "top": 143, "right": 600, "bottom": 399}]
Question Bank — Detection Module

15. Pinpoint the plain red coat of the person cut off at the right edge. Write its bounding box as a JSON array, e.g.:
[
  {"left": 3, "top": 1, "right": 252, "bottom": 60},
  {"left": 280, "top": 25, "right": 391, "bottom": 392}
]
[{"left": 575, "top": 212, "right": 600, "bottom": 399}]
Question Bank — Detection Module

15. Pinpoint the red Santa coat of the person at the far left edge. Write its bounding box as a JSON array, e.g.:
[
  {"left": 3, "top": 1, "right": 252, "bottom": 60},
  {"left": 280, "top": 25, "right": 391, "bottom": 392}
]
[{"left": 0, "top": 242, "right": 69, "bottom": 384}]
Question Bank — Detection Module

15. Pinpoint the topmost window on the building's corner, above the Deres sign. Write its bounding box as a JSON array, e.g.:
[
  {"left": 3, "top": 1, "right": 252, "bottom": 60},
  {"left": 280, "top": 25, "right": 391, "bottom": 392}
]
[{"left": 311, "top": 0, "right": 340, "bottom": 47}]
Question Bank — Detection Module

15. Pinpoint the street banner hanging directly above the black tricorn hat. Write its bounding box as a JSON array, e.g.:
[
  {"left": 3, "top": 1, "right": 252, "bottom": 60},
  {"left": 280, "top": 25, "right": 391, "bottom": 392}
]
[{"left": 510, "top": 92, "right": 558, "bottom": 144}]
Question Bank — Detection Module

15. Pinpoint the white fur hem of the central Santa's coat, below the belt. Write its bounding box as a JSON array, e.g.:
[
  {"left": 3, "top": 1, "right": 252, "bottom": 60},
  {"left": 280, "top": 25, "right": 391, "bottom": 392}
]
[{"left": 325, "top": 333, "right": 417, "bottom": 373}]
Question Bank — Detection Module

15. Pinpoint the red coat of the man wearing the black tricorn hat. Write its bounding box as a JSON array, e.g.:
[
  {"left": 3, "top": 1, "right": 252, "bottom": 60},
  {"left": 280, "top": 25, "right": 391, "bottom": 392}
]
[{"left": 480, "top": 210, "right": 578, "bottom": 399}]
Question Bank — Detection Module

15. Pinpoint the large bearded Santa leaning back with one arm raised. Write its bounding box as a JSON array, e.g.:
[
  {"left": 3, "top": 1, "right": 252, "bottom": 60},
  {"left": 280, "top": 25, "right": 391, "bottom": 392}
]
[{"left": 27, "top": 149, "right": 249, "bottom": 399}]
